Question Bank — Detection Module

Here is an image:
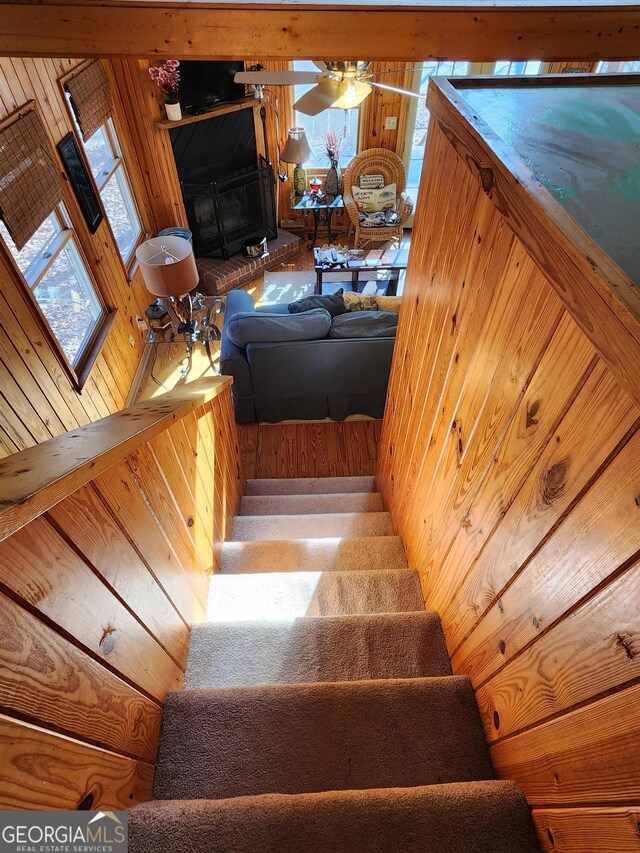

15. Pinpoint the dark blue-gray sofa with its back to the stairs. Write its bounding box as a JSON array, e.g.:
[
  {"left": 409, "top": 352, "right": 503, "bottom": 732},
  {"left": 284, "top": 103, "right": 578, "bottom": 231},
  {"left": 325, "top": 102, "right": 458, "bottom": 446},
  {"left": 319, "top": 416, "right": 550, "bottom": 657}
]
[{"left": 220, "top": 290, "right": 397, "bottom": 423}]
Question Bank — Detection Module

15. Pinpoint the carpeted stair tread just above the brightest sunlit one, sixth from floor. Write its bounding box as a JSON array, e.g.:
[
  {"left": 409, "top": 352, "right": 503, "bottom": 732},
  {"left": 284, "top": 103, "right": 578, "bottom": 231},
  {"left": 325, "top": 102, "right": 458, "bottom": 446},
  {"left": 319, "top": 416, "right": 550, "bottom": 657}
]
[{"left": 184, "top": 611, "right": 451, "bottom": 689}]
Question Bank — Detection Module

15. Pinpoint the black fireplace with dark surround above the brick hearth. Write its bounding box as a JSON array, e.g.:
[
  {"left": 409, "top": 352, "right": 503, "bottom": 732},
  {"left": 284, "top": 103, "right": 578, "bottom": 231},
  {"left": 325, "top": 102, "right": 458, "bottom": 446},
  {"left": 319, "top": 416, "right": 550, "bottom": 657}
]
[{"left": 171, "top": 101, "right": 278, "bottom": 259}]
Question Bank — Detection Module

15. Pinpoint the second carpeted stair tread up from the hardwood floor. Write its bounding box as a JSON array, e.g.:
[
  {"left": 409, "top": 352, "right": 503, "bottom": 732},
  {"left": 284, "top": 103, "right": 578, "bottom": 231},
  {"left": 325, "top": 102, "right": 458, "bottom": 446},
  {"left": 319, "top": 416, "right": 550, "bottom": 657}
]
[{"left": 240, "top": 492, "right": 384, "bottom": 515}]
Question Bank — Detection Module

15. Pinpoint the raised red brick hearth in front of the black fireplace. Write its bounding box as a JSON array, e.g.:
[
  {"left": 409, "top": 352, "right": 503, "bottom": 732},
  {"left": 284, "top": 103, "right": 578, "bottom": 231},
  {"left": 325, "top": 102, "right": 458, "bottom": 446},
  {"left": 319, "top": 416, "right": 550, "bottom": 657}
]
[{"left": 196, "top": 230, "right": 302, "bottom": 296}]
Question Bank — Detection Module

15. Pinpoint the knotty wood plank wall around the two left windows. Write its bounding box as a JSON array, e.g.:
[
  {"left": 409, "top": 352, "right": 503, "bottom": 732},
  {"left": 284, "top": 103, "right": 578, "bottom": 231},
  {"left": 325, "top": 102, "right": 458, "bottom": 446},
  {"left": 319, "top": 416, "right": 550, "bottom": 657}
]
[{"left": 0, "top": 58, "right": 155, "bottom": 457}]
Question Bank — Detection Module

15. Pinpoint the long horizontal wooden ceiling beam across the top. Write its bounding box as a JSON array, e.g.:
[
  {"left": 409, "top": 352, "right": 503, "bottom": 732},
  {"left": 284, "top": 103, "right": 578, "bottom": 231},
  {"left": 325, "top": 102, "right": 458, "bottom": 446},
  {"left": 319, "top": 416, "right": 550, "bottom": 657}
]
[{"left": 0, "top": 0, "right": 640, "bottom": 62}]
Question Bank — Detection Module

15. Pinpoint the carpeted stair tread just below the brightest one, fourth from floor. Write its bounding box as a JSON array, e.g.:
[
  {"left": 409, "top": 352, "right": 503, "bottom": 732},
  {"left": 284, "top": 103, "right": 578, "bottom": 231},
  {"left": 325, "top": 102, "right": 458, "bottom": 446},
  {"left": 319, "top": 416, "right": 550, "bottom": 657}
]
[{"left": 221, "top": 536, "right": 407, "bottom": 573}]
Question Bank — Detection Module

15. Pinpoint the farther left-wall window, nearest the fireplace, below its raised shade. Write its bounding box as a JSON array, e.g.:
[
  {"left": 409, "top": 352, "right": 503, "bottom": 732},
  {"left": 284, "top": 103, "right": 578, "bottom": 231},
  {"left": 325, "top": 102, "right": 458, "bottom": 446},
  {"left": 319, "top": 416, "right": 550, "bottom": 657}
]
[{"left": 71, "top": 110, "right": 142, "bottom": 266}]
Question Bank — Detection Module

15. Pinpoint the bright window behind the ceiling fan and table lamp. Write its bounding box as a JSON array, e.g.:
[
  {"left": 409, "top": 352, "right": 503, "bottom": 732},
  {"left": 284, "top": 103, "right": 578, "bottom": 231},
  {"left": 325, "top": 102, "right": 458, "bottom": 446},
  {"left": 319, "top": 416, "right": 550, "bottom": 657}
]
[{"left": 293, "top": 61, "right": 360, "bottom": 169}]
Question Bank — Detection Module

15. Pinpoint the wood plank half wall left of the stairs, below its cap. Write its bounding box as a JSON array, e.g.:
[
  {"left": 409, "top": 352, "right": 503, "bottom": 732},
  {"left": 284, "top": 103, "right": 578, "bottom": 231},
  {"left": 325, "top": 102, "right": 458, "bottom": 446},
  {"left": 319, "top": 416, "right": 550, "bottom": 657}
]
[{"left": 0, "top": 386, "right": 244, "bottom": 809}]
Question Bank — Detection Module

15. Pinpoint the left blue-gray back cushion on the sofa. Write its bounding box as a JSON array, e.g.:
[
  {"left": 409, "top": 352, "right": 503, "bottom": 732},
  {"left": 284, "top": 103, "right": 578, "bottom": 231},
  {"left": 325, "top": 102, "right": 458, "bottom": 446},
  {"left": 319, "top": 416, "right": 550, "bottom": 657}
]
[{"left": 225, "top": 308, "right": 331, "bottom": 347}]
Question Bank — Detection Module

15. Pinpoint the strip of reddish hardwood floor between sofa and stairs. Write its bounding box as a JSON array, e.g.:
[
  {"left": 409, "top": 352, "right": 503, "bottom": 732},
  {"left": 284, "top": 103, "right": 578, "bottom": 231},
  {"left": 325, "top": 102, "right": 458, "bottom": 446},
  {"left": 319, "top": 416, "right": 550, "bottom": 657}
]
[{"left": 238, "top": 420, "right": 382, "bottom": 479}]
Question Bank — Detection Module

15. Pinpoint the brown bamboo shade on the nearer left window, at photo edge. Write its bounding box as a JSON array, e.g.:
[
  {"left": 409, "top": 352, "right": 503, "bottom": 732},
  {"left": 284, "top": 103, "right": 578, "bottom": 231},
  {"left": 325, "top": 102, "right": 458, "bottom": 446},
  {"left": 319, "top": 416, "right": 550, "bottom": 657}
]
[{"left": 0, "top": 109, "right": 63, "bottom": 249}]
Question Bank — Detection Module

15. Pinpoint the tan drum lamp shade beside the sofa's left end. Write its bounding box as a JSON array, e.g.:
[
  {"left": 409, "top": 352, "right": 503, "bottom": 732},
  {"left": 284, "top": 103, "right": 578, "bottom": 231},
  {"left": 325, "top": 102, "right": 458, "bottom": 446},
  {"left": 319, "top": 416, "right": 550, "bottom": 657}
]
[{"left": 136, "top": 237, "right": 200, "bottom": 296}]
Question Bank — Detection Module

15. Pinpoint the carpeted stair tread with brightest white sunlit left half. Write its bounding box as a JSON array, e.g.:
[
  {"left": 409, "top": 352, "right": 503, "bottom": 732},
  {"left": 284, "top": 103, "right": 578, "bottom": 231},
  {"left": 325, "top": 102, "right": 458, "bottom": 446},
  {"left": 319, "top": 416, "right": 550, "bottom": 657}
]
[{"left": 206, "top": 569, "right": 424, "bottom": 622}]
